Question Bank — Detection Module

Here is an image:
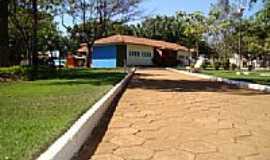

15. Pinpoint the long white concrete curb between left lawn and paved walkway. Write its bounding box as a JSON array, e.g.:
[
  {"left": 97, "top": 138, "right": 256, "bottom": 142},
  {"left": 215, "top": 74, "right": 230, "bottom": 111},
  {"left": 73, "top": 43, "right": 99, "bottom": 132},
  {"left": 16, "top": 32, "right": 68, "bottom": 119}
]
[{"left": 37, "top": 68, "right": 136, "bottom": 160}]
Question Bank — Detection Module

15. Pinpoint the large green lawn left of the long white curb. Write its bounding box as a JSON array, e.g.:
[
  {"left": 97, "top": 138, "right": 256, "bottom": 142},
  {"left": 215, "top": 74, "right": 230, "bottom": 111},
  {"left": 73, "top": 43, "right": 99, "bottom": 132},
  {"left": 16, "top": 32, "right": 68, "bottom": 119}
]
[{"left": 0, "top": 69, "right": 125, "bottom": 160}]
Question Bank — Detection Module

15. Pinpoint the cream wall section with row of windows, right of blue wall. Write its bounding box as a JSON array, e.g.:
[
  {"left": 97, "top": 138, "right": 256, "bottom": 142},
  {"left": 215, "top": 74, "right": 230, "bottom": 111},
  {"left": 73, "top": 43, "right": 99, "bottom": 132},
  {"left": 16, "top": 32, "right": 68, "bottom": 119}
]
[{"left": 127, "top": 45, "right": 154, "bottom": 66}]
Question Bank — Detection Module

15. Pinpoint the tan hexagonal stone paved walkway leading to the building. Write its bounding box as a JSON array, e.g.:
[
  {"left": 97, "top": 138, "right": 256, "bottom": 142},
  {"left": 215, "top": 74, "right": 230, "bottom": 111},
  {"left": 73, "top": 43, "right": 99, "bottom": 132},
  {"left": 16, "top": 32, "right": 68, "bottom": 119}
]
[{"left": 86, "top": 69, "right": 270, "bottom": 160}]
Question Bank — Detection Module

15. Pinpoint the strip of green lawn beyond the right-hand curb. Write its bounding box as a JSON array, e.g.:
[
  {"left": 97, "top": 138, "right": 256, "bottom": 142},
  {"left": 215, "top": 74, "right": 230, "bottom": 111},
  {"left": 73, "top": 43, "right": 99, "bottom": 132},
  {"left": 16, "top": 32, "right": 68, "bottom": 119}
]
[{"left": 202, "top": 70, "right": 270, "bottom": 85}]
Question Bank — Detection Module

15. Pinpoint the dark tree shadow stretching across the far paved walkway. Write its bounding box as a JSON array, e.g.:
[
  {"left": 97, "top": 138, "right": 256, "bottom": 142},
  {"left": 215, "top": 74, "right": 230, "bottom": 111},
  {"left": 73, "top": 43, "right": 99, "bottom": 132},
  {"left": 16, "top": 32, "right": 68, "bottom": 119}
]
[{"left": 129, "top": 74, "right": 267, "bottom": 96}]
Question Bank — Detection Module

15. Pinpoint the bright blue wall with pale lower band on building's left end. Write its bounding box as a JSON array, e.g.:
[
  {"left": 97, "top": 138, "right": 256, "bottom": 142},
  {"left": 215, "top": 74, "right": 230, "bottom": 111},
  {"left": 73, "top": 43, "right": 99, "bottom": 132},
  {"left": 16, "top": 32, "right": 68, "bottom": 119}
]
[{"left": 92, "top": 45, "right": 117, "bottom": 68}]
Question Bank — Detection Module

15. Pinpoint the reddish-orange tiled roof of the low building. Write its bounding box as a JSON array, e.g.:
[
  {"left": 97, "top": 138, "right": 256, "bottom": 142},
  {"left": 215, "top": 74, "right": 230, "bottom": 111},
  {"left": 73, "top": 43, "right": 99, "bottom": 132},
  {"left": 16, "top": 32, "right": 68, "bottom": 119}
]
[{"left": 95, "top": 35, "right": 189, "bottom": 51}]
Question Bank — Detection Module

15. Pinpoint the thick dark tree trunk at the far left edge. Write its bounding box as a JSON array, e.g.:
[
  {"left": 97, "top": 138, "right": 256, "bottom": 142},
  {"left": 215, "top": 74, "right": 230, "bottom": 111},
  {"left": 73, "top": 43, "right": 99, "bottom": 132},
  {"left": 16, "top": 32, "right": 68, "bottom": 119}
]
[{"left": 0, "top": 0, "right": 9, "bottom": 67}]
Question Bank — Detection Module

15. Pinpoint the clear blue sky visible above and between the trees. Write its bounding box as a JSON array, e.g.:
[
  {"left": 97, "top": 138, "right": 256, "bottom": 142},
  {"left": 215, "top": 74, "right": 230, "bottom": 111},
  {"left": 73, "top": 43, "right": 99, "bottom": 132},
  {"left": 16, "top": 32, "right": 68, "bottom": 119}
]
[{"left": 56, "top": 0, "right": 261, "bottom": 31}]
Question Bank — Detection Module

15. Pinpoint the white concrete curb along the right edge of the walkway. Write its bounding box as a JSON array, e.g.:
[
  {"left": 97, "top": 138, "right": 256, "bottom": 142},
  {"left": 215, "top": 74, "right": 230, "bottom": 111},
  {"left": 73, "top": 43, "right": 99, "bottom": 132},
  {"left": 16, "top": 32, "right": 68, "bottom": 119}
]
[{"left": 166, "top": 68, "right": 270, "bottom": 93}]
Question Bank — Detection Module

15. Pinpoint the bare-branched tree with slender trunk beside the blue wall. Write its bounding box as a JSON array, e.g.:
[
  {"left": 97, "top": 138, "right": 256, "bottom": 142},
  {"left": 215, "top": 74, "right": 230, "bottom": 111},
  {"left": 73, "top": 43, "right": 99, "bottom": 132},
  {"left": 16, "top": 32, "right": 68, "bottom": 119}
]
[{"left": 60, "top": 0, "right": 142, "bottom": 67}]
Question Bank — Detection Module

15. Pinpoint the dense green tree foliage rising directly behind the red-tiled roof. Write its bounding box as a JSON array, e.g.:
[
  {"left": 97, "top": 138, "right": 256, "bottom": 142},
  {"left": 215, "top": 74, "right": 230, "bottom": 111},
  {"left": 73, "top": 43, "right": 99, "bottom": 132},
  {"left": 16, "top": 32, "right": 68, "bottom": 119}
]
[{"left": 123, "top": 12, "right": 207, "bottom": 52}]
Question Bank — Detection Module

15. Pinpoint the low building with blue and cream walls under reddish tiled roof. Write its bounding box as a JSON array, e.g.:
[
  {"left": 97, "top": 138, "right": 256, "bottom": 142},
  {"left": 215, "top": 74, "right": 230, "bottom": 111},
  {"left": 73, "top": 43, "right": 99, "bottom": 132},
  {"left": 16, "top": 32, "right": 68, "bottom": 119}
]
[{"left": 78, "top": 35, "right": 191, "bottom": 68}]
